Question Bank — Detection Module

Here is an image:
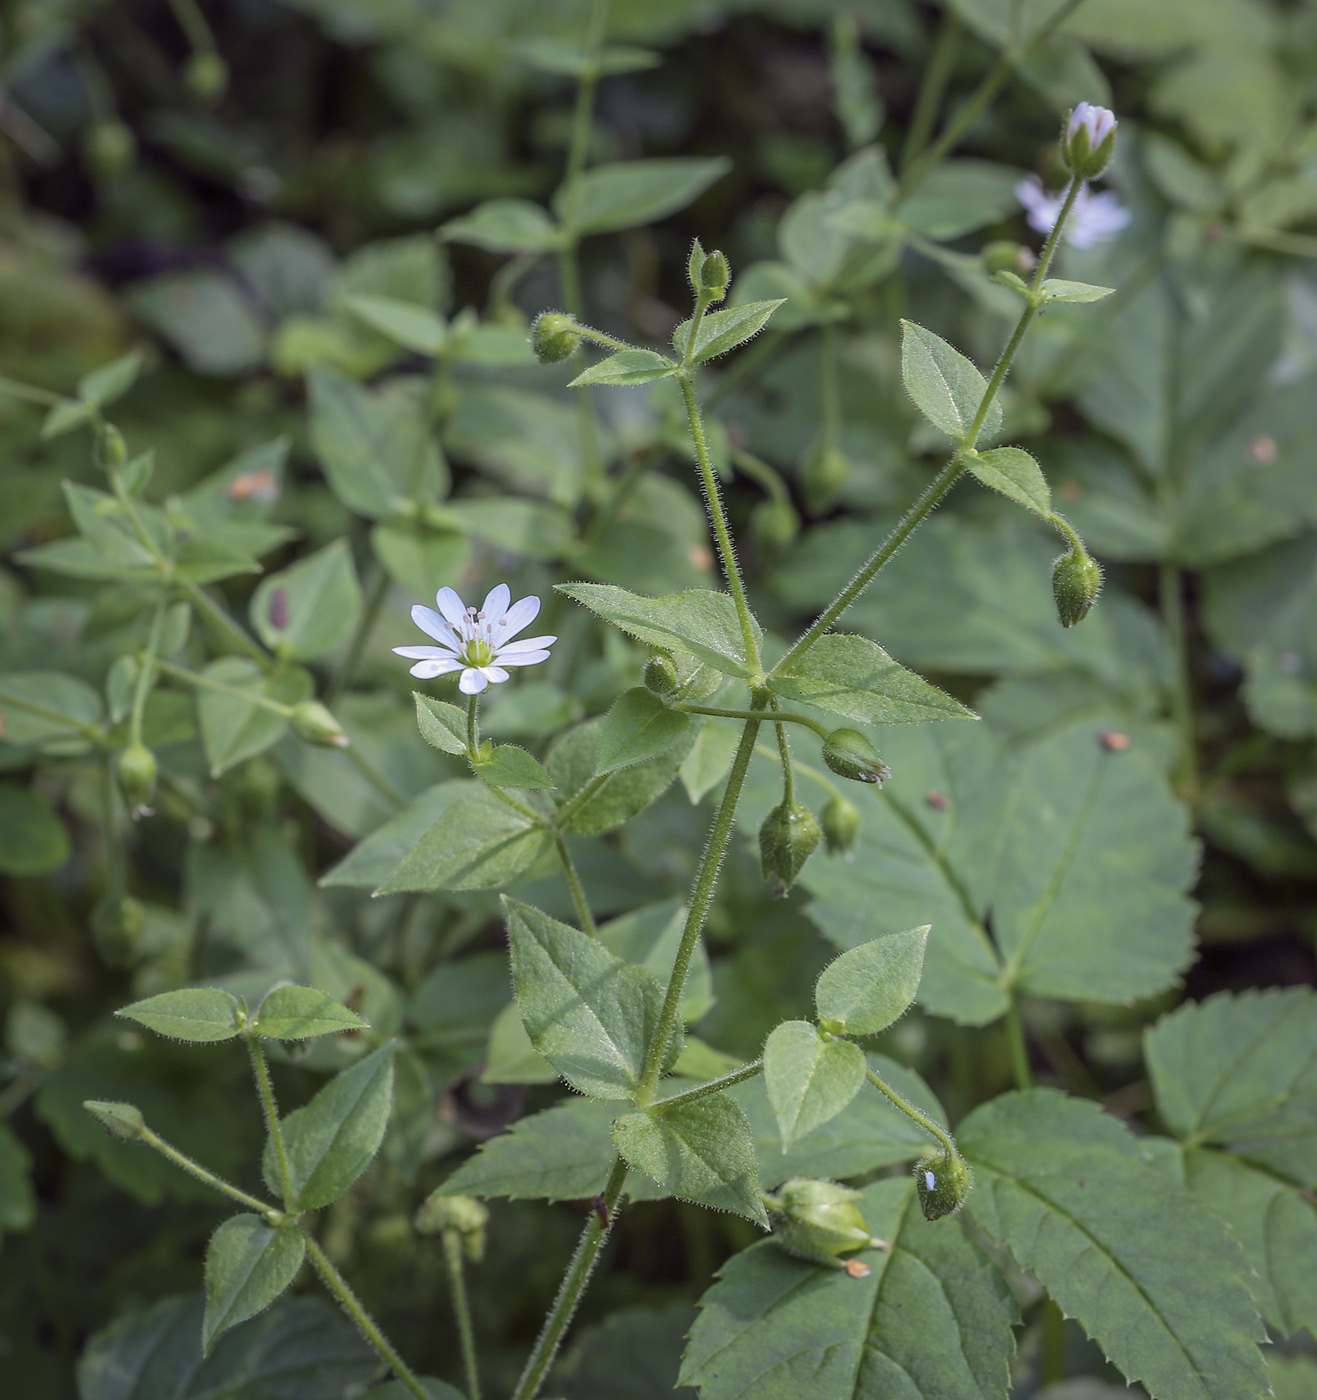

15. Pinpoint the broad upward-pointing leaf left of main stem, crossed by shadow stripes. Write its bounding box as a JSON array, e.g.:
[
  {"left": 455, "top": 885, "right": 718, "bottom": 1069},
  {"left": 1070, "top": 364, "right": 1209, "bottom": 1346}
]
[{"left": 504, "top": 899, "right": 663, "bottom": 1099}]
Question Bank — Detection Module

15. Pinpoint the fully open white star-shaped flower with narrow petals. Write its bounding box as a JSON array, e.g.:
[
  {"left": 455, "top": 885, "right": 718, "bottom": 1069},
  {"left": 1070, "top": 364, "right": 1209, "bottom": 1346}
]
[{"left": 393, "top": 584, "right": 558, "bottom": 696}]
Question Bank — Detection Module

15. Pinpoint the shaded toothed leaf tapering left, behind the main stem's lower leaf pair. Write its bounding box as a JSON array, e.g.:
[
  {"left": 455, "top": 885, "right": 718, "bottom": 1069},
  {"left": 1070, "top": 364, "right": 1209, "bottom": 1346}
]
[{"left": 431, "top": 1098, "right": 619, "bottom": 1201}]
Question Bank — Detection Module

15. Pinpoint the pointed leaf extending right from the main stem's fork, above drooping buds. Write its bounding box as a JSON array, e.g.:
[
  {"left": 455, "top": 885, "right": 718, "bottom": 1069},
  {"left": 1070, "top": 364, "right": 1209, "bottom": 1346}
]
[{"left": 768, "top": 633, "right": 976, "bottom": 724}]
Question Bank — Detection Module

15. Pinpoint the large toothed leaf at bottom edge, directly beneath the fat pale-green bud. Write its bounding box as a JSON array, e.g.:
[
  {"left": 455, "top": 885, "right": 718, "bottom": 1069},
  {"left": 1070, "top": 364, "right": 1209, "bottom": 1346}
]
[{"left": 680, "top": 1177, "right": 1017, "bottom": 1400}]
